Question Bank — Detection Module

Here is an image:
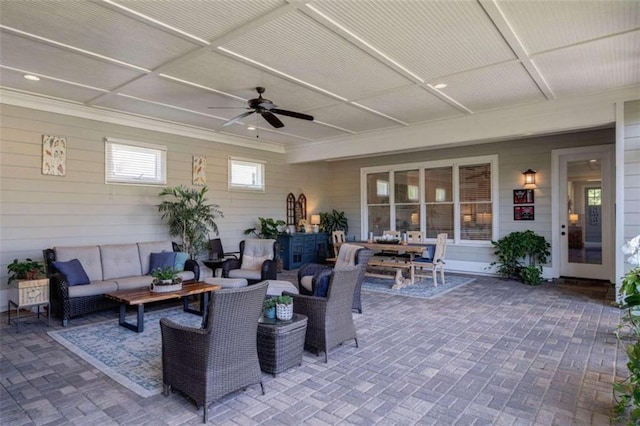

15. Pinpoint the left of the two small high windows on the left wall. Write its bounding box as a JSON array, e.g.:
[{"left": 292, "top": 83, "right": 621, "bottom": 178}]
[{"left": 104, "top": 138, "right": 167, "bottom": 185}]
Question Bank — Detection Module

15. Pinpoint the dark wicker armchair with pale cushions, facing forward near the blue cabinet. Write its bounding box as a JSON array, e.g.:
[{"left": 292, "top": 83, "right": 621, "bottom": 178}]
[{"left": 222, "top": 239, "right": 280, "bottom": 284}]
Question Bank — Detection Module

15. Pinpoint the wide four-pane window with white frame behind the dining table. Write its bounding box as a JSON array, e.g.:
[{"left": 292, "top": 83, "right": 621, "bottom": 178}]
[{"left": 362, "top": 156, "right": 497, "bottom": 242}]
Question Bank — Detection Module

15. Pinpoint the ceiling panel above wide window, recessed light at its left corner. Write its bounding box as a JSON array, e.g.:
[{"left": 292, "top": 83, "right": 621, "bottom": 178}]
[{"left": 433, "top": 62, "right": 545, "bottom": 112}]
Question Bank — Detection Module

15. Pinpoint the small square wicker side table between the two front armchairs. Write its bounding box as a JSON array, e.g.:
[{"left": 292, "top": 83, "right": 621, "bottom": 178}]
[{"left": 258, "top": 314, "right": 307, "bottom": 377}]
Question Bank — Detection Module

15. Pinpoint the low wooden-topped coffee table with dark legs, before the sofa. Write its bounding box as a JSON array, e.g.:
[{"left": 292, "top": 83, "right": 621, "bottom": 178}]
[{"left": 105, "top": 282, "right": 220, "bottom": 333}]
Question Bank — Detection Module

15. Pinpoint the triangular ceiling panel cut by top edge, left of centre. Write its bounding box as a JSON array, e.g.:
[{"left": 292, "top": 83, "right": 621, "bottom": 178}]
[{"left": 116, "top": 0, "right": 286, "bottom": 41}]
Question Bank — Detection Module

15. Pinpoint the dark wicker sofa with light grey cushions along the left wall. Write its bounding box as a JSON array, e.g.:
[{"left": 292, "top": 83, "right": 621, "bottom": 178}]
[{"left": 43, "top": 241, "right": 200, "bottom": 327}]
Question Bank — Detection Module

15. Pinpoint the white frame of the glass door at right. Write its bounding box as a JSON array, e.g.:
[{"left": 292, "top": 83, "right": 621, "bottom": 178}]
[{"left": 551, "top": 145, "right": 616, "bottom": 282}]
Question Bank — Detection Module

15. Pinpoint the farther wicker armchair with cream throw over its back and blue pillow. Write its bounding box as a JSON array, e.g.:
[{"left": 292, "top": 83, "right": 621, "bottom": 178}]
[{"left": 298, "top": 244, "right": 373, "bottom": 313}]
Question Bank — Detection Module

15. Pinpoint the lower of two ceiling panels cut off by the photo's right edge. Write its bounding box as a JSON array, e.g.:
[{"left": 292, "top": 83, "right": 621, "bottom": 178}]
[{"left": 533, "top": 31, "right": 640, "bottom": 96}]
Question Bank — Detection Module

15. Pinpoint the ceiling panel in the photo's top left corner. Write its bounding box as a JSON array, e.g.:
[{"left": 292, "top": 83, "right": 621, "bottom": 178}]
[{"left": 0, "top": 1, "right": 197, "bottom": 69}]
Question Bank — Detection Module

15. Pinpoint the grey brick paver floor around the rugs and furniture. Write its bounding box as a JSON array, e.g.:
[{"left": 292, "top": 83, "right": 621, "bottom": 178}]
[{"left": 0, "top": 277, "right": 626, "bottom": 425}]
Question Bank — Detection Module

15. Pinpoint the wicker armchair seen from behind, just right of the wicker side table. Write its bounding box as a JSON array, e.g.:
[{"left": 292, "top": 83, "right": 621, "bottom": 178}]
[{"left": 282, "top": 266, "right": 360, "bottom": 362}]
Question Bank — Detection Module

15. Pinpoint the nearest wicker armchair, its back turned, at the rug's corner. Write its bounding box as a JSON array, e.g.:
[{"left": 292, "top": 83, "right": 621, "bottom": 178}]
[{"left": 160, "top": 283, "right": 268, "bottom": 423}]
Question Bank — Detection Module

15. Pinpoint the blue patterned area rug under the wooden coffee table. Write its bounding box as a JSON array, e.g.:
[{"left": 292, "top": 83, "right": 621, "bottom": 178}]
[{"left": 48, "top": 308, "right": 202, "bottom": 398}]
